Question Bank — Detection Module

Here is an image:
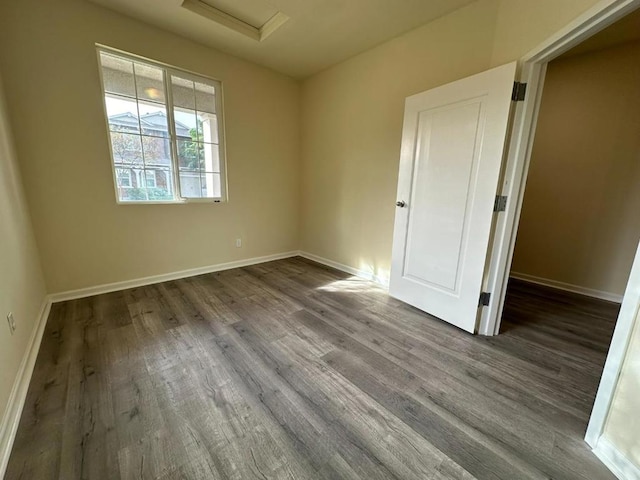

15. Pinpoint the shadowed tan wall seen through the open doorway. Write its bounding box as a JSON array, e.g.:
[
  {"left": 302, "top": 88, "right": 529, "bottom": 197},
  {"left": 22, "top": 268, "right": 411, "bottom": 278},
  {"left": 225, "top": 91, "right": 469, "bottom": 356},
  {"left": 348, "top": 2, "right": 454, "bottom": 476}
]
[{"left": 512, "top": 43, "right": 640, "bottom": 295}]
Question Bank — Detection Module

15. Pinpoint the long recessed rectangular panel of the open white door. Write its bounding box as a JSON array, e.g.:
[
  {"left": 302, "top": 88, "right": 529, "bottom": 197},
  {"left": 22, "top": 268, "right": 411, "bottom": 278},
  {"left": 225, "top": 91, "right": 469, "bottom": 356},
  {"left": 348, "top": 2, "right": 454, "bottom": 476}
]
[{"left": 404, "top": 100, "right": 483, "bottom": 292}]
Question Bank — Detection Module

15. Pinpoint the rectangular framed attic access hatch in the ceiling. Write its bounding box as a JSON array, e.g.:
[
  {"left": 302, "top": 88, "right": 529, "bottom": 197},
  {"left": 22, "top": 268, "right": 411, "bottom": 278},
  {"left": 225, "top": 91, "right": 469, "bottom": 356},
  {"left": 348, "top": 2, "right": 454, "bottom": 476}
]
[{"left": 182, "top": 0, "right": 289, "bottom": 42}]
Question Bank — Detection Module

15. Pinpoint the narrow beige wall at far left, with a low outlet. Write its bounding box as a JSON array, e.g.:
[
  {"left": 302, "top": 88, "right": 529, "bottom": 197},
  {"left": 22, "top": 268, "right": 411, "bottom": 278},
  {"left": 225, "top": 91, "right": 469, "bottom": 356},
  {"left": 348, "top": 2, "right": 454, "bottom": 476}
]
[{"left": 0, "top": 75, "right": 46, "bottom": 442}]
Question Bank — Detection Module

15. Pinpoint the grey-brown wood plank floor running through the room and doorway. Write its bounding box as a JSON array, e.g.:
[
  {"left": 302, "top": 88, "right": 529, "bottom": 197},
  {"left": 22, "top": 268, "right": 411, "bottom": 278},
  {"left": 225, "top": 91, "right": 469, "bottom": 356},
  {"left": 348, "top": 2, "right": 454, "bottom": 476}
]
[{"left": 6, "top": 258, "right": 618, "bottom": 480}]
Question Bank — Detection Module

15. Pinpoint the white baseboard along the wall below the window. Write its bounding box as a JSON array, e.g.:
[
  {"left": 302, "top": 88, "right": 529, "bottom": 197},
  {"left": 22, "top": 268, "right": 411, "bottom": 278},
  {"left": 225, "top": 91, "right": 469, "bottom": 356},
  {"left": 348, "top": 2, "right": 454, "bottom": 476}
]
[{"left": 50, "top": 251, "right": 299, "bottom": 303}]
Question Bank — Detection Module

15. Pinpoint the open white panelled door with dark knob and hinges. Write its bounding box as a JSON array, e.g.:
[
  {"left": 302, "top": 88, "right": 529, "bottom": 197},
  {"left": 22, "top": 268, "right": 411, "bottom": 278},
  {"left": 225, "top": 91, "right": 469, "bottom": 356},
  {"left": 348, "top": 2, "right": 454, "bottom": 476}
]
[{"left": 389, "top": 62, "right": 516, "bottom": 333}]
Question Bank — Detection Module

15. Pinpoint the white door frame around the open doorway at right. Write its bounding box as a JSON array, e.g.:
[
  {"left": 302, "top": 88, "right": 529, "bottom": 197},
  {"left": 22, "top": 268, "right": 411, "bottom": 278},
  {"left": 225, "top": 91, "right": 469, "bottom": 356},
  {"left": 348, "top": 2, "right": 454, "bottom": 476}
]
[{"left": 478, "top": 0, "right": 640, "bottom": 449}]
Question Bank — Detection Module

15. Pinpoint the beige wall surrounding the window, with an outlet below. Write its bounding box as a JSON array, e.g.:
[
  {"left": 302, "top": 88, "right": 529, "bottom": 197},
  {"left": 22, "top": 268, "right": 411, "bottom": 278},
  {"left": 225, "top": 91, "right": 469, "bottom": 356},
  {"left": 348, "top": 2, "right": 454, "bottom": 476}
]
[{"left": 0, "top": 0, "right": 300, "bottom": 293}]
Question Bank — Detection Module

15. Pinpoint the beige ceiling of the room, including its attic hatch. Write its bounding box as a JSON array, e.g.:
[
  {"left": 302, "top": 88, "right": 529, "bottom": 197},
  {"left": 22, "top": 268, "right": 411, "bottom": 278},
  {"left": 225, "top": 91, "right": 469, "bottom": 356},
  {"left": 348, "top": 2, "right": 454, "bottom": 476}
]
[{"left": 89, "top": 0, "right": 474, "bottom": 78}]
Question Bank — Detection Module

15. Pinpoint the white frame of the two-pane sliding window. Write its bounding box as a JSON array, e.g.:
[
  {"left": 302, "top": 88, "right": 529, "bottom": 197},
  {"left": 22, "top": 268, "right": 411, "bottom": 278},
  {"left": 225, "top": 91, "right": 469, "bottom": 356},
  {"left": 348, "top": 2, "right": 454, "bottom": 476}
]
[{"left": 96, "top": 44, "right": 228, "bottom": 205}]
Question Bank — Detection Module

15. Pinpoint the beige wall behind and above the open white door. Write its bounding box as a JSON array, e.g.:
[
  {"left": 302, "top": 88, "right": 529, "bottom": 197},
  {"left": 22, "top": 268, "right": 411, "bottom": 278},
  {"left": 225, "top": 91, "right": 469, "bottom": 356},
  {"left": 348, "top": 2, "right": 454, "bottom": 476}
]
[{"left": 301, "top": 0, "right": 596, "bottom": 277}]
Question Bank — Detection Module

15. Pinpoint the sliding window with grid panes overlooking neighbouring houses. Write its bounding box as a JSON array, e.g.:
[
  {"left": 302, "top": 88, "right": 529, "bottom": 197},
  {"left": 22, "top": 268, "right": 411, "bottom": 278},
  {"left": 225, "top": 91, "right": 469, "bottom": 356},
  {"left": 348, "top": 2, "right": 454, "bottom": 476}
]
[{"left": 98, "top": 47, "right": 226, "bottom": 203}]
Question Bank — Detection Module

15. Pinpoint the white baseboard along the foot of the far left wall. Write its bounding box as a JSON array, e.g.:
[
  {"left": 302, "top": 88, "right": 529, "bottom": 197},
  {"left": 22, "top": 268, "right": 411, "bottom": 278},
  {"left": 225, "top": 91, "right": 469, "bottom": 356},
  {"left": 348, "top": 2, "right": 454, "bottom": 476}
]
[{"left": 0, "top": 296, "right": 51, "bottom": 478}]
